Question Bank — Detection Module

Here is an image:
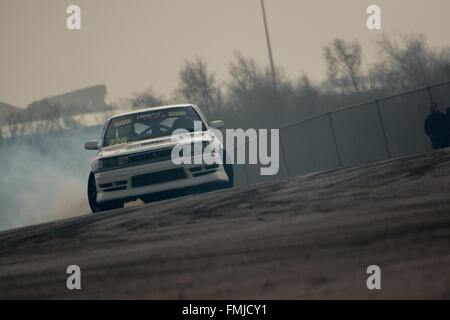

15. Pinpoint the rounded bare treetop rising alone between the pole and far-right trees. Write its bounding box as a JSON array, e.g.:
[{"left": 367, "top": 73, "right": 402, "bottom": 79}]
[{"left": 323, "top": 39, "right": 362, "bottom": 93}]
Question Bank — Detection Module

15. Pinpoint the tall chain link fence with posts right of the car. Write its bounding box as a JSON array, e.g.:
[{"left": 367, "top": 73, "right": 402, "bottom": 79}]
[{"left": 234, "top": 81, "right": 450, "bottom": 186}]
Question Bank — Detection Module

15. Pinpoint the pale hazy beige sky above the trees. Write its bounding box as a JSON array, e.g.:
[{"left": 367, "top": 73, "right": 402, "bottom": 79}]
[{"left": 0, "top": 0, "right": 450, "bottom": 107}]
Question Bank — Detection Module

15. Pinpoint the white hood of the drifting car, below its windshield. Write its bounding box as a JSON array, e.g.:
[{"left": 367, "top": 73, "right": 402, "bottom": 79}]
[{"left": 98, "top": 131, "right": 211, "bottom": 158}]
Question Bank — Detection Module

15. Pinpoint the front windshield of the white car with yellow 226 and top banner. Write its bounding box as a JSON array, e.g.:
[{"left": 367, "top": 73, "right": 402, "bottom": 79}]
[{"left": 103, "top": 107, "right": 206, "bottom": 147}]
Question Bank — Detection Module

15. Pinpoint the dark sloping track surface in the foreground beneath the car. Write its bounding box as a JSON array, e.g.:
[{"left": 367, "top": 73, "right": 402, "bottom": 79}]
[{"left": 0, "top": 150, "right": 450, "bottom": 299}]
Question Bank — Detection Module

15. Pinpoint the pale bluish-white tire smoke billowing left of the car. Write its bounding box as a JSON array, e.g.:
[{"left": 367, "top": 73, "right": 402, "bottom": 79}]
[{"left": 0, "top": 128, "right": 101, "bottom": 230}]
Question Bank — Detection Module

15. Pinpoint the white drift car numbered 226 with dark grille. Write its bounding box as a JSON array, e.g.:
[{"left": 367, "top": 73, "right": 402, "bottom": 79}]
[{"left": 85, "top": 105, "right": 233, "bottom": 213}]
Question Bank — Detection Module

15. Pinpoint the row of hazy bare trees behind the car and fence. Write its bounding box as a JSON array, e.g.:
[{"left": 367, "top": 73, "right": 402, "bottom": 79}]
[{"left": 130, "top": 35, "right": 450, "bottom": 128}]
